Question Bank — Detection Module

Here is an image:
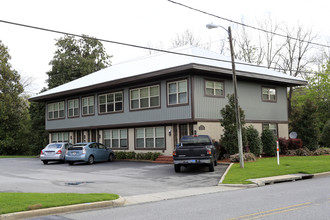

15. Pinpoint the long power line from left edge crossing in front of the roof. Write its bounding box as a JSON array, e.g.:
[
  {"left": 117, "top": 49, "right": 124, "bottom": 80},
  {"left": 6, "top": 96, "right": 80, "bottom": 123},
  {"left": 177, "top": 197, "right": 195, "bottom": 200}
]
[{"left": 0, "top": 20, "right": 324, "bottom": 74}]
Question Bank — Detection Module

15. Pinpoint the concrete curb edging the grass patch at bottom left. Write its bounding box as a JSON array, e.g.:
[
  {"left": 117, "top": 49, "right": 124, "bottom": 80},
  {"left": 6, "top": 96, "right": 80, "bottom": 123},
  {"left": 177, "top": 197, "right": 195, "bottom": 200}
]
[{"left": 0, "top": 197, "right": 126, "bottom": 220}]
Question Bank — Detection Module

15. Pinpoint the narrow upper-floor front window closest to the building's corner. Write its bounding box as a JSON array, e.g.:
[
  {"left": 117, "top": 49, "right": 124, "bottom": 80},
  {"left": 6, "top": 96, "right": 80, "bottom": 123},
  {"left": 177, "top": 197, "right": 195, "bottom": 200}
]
[{"left": 167, "top": 80, "right": 188, "bottom": 105}]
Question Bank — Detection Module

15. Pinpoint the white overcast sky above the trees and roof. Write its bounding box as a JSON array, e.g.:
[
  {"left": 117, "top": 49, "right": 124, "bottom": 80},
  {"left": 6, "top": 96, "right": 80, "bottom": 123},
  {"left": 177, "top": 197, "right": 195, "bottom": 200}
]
[{"left": 0, "top": 0, "right": 330, "bottom": 94}]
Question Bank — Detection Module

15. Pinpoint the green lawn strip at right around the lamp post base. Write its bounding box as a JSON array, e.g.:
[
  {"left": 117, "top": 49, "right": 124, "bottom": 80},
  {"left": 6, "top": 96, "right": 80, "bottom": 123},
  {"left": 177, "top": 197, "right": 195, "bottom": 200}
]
[{"left": 223, "top": 155, "right": 330, "bottom": 184}]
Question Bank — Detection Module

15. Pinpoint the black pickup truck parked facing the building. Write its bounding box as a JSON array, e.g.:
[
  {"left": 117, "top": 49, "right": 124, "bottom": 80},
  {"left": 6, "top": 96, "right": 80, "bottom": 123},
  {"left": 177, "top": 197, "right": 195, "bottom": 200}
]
[{"left": 173, "top": 135, "right": 217, "bottom": 172}]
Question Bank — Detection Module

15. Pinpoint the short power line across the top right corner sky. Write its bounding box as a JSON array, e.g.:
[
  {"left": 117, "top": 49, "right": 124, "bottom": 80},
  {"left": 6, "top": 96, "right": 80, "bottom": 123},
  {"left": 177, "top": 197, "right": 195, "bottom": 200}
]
[{"left": 168, "top": 0, "right": 330, "bottom": 48}]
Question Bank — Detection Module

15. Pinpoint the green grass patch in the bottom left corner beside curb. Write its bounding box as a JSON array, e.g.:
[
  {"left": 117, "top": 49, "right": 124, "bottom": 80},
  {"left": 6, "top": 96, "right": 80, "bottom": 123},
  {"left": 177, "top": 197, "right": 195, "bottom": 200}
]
[{"left": 0, "top": 192, "right": 119, "bottom": 214}]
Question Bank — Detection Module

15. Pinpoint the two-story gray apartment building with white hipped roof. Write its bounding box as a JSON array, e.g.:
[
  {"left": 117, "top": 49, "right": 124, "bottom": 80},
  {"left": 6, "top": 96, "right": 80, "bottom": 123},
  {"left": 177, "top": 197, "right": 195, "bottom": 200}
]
[{"left": 30, "top": 46, "right": 306, "bottom": 155}]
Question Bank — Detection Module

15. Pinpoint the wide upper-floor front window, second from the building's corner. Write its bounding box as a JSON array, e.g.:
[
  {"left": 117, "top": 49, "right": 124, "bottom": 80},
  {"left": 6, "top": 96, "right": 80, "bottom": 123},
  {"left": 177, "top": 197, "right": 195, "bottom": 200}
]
[{"left": 130, "top": 85, "right": 160, "bottom": 110}]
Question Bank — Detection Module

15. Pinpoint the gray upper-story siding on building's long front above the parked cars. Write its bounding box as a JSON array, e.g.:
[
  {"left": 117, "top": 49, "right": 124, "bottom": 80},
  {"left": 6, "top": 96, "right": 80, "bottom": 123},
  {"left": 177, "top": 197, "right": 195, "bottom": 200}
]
[{"left": 46, "top": 80, "right": 192, "bottom": 130}]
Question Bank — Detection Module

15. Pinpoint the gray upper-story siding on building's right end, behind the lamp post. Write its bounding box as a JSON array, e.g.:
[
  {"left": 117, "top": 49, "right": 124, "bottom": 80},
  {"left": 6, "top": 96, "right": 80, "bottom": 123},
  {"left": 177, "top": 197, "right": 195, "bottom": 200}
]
[{"left": 194, "top": 76, "right": 288, "bottom": 121}]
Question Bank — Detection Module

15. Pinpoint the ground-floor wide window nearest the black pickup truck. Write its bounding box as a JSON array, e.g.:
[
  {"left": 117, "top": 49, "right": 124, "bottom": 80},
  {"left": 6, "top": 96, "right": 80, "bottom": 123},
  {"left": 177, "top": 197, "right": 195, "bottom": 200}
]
[{"left": 135, "top": 127, "right": 165, "bottom": 149}]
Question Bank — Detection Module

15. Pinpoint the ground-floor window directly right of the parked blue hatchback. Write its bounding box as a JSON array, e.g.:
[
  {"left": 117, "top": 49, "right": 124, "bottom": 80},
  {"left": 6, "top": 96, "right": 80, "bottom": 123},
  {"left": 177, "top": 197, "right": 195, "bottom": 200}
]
[{"left": 103, "top": 129, "right": 128, "bottom": 148}]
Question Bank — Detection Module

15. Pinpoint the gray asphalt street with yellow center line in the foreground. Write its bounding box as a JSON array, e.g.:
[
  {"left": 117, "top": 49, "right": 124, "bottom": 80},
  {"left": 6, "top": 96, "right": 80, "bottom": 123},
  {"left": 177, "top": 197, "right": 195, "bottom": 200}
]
[{"left": 42, "top": 176, "right": 330, "bottom": 220}]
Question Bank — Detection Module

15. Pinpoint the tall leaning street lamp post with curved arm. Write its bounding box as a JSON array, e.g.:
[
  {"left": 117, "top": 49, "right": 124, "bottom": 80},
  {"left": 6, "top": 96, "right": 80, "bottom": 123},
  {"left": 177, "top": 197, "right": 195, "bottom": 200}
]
[{"left": 206, "top": 23, "right": 244, "bottom": 168}]
